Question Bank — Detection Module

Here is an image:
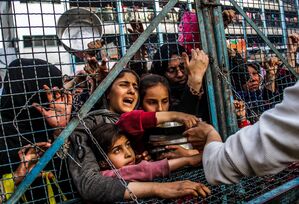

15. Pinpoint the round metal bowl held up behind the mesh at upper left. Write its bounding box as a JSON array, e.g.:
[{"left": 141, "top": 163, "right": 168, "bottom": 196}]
[{"left": 56, "top": 8, "right": 103, "bottom": 58}]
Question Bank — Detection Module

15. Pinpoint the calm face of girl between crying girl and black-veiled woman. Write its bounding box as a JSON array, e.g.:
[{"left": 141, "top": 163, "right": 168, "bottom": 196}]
[{"left": 142, "top": 83, "right": 169, "bottom": 112}]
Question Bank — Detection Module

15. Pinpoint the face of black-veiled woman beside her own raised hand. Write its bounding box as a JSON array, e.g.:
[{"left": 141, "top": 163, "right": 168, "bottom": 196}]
[{"left": 165, "top": 55, "right": 187, "bottom": 84}]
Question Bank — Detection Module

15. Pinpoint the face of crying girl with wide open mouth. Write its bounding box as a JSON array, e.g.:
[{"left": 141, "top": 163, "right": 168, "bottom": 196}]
[{"left": 107, "top": 73, "right": 139, "bottom": 113}]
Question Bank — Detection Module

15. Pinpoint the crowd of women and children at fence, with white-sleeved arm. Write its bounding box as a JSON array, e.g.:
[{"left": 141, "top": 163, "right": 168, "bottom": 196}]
[{"left": 0, "top": 6, "right": 299, "bottom": 203}]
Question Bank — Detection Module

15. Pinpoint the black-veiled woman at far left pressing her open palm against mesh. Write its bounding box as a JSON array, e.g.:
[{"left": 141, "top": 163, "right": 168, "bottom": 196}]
[{"left": 0, "top": 59, "right": 72, "bottom": 203}]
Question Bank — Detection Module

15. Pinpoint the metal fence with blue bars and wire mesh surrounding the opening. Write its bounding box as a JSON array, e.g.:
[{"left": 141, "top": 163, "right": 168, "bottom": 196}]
[{"left": 0, "top": 0, "right": 299, "bottom": 203}]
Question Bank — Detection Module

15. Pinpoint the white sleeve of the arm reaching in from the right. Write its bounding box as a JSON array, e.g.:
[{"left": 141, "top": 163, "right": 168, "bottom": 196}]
[{"left": 203, "top": 82, "right": 299, "bottom": 184}]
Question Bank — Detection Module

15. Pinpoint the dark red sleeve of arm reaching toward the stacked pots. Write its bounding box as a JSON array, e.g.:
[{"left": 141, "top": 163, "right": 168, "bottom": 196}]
[{"left": 116, "top": 110, "right": 157, "bottom": 136}]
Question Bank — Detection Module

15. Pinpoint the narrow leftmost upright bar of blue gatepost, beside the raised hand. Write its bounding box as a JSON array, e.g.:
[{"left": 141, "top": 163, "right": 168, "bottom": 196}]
[{"left": 196, "top": 0, "right": 219, "bottom": 130}]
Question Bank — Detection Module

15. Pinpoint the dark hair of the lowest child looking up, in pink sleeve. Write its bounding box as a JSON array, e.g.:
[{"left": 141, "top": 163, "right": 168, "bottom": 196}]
[{"left": 91, "top": 123, "right": 122, "bottom": 161}]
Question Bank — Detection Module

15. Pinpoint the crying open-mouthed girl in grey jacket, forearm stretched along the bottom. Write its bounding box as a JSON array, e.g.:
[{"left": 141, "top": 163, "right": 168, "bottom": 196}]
[{"left": 69, "top": 69, "right": 209, "bottom": 203}]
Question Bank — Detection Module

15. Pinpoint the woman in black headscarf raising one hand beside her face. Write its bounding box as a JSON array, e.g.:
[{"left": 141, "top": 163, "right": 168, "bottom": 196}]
[{"left": 151, "top": 44, "right": 209, "bottom": 121}]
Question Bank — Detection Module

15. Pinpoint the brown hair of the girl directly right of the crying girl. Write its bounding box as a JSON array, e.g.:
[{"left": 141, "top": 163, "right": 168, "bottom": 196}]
[{"left": 139, "top": 74, "right": 170, "bottom": 103}]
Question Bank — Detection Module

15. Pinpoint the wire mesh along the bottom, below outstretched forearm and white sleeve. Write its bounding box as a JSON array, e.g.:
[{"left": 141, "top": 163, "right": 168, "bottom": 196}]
[{"left": 118, "top": 165, "right": 298, "bottom": 203}]
